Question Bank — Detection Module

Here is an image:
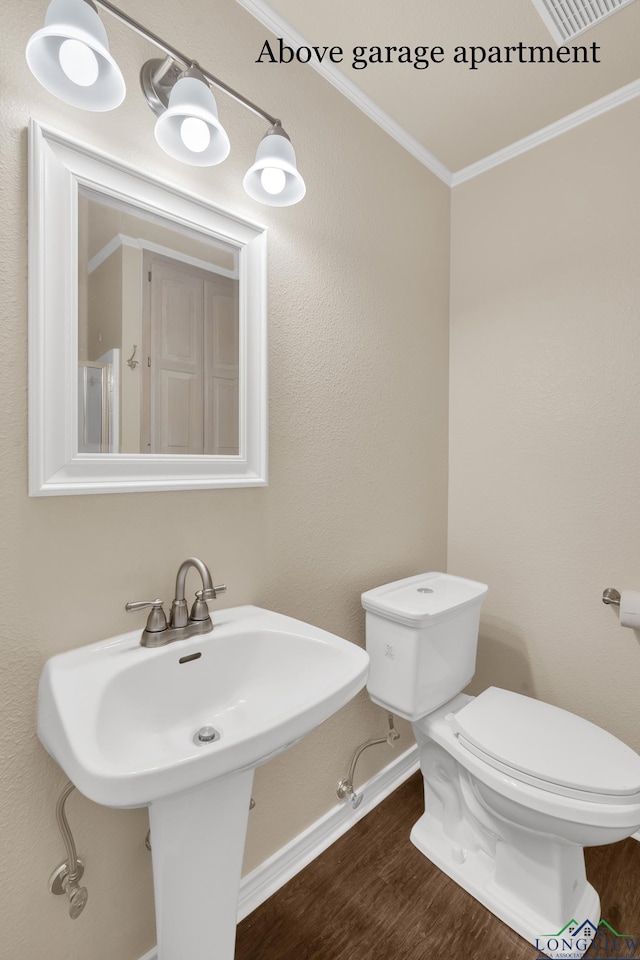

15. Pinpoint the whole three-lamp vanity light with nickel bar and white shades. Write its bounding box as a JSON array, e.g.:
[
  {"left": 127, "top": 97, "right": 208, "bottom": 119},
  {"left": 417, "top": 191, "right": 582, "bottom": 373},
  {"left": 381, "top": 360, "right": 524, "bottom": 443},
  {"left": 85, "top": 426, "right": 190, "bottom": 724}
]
[{"left": 26, "top": 0, "right": 306, "bottom": 207}]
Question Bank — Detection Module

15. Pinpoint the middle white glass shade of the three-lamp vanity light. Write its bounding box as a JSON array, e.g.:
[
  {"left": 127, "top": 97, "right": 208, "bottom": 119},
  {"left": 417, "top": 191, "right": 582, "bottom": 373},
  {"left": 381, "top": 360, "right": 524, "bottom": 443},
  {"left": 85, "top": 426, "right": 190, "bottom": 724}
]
[{"left": 155, "top": 77, "right": 231, "bottom": 167}]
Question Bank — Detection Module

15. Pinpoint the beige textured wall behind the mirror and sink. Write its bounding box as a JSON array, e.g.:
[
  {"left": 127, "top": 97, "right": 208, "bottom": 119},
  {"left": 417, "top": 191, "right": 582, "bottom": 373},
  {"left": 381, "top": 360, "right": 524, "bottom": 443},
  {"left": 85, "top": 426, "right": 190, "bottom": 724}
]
[{"left": 0, "top": 0, "right": 449, "bottom": 960}]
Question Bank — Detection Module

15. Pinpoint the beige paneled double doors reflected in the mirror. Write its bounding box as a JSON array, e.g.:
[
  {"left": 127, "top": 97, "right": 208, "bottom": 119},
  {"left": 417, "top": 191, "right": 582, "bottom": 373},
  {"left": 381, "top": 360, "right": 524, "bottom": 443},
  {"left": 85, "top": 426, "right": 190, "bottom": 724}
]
[{"left": 141, "top": 253, "right": 239, "bottom": 456}]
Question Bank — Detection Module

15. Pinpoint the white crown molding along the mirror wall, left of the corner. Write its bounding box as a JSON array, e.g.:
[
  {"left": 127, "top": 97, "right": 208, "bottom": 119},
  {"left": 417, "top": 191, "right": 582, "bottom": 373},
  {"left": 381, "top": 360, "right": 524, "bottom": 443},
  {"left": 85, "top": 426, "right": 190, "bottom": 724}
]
[{"left": 237, "top": 0, "right": 452, "bottom": 187}]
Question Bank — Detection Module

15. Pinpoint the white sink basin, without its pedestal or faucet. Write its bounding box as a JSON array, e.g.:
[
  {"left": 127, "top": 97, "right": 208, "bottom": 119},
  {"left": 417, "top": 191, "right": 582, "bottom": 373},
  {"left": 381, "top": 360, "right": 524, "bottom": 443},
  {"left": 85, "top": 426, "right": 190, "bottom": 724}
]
[{"left": 38, "top": 606, "right": 369, "bottom": 807}]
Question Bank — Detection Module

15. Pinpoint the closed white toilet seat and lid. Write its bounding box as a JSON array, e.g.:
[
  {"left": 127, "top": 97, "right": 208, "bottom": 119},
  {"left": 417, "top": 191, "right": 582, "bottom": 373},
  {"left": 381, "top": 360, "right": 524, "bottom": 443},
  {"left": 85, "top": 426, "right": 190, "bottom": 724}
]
[{"left": 448, "top": 687, "right": 640, "bottom": 805}]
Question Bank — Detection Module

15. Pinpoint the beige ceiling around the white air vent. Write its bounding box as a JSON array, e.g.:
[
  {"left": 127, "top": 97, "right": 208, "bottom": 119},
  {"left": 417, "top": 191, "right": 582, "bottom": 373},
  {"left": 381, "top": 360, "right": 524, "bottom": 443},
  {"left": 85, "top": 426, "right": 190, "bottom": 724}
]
[{"left": 239, "top": 0, "right": 640, "bottom": 174}]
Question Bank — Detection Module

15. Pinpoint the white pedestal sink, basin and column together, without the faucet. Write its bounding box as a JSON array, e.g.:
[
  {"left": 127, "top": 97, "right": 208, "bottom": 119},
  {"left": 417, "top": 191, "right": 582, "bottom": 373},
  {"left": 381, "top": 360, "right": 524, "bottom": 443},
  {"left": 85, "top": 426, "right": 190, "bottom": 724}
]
[{"left": 38, "top": 606, "right": 369, "bottom": 960}]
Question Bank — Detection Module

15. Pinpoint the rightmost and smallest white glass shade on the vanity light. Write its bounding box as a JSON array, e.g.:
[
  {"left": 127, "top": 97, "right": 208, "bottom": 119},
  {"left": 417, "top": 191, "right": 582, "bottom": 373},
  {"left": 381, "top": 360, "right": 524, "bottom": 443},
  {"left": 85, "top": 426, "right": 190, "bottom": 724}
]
[{"left": 243, "top": 128, "right": 307, "bottom": 207}]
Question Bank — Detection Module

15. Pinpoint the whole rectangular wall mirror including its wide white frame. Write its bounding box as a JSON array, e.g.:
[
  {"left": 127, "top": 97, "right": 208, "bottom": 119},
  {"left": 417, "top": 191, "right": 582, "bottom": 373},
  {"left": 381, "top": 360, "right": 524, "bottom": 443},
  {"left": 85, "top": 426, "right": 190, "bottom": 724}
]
[{"left": 29, "top": 121, "right": 267, "bottom": 496}]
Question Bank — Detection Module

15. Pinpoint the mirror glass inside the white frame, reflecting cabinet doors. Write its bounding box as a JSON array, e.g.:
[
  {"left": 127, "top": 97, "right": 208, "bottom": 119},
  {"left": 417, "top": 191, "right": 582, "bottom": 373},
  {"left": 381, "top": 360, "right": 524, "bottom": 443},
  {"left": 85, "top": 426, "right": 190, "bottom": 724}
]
[{"left": 78, "top": 187, "right": 239, "bottom": 456}]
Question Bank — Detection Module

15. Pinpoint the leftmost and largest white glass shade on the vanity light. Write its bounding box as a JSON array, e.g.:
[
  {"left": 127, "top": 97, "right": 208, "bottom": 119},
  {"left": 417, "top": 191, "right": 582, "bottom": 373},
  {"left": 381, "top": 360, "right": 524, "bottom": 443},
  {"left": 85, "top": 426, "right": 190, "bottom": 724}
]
[{"left": 26, "top": 0, "right": 126, "bottom": 111}]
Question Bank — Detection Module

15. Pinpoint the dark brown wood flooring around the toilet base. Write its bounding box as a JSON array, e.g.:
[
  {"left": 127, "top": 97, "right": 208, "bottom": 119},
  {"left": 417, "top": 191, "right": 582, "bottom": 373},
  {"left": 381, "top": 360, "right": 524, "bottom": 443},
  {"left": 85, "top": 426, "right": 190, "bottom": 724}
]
[{"left": 236, "top": 773, "right": 640, "bottom": 960}]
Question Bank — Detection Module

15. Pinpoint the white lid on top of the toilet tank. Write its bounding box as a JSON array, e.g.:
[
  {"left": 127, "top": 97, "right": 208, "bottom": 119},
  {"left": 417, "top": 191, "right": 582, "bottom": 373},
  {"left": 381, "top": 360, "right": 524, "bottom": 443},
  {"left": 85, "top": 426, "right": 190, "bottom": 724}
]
[{"left": 362, "top": 572, "right": 488, "bottom": 626}]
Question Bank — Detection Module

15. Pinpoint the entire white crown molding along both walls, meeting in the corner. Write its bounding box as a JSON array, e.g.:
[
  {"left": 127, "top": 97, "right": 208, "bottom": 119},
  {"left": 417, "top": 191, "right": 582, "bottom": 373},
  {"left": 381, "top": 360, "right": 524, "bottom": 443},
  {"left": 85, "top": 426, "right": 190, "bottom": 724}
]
[{"left": 237, "top": 0, "right": 640, "bottom": 187}]
